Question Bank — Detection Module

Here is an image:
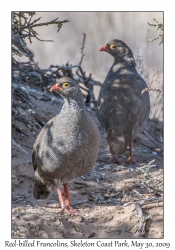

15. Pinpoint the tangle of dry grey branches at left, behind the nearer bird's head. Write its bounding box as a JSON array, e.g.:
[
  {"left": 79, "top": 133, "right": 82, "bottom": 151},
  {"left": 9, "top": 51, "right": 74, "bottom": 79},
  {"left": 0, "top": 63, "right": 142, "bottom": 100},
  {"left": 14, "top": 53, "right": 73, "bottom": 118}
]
[{"left": 12, "top": 15, "right": 101, "bottom": 141}]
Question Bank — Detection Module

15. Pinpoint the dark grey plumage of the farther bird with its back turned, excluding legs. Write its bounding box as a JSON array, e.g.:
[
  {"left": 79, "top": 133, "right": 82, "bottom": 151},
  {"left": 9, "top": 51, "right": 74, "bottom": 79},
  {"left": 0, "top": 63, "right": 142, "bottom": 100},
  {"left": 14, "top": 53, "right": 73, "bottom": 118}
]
[{"left": 98, "top": 39, "right": 150, "bottom": 155}]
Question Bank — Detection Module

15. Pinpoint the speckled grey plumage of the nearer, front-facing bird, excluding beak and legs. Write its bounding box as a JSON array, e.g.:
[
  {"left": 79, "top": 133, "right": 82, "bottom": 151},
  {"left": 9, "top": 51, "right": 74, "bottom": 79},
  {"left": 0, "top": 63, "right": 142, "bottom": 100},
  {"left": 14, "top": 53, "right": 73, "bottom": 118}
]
[{"left": 33, "top": 77, "right": 100, "bottom": 198}]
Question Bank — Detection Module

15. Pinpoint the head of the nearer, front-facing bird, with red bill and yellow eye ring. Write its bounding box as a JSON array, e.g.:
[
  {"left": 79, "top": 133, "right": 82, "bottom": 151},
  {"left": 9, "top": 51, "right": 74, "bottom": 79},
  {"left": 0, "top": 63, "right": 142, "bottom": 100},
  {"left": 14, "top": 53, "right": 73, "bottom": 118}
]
[{"left": 50, "top": 77, "right": 79, "bottom": 98}]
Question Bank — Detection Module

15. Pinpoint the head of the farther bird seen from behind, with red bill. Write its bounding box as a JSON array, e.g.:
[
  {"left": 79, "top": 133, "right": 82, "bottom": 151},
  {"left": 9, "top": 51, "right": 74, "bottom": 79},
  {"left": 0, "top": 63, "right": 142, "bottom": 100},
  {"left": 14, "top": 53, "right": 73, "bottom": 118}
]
[{"left": 100, "top": 39, "right": 133, "bottom": 60}]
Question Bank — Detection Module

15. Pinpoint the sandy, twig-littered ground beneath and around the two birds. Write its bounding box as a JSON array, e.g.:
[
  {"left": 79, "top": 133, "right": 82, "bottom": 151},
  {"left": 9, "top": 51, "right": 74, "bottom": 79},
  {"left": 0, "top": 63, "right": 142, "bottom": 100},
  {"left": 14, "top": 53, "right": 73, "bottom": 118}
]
[{"left": 11, "top": 93, "right": 163, "bottom": 239}]
